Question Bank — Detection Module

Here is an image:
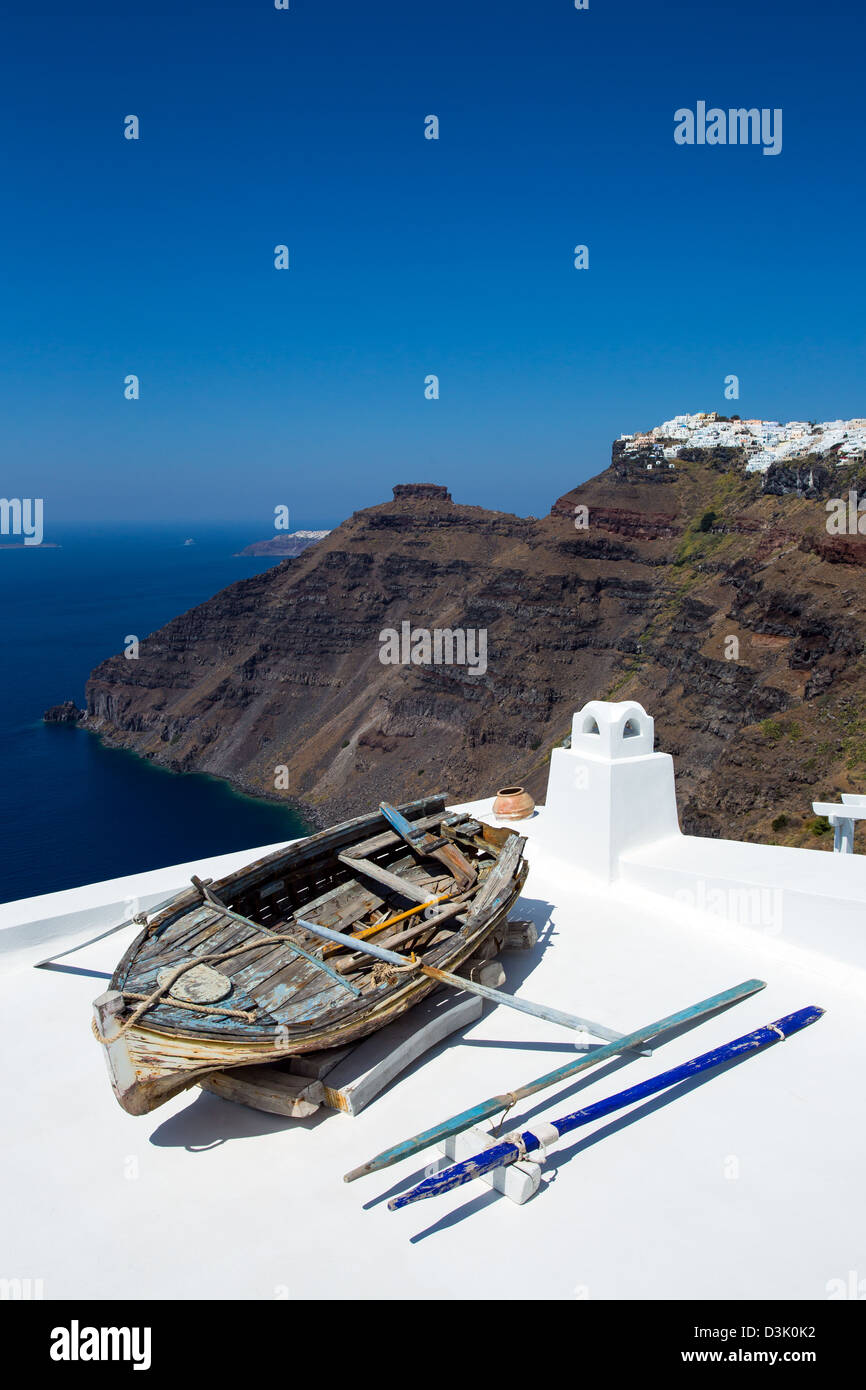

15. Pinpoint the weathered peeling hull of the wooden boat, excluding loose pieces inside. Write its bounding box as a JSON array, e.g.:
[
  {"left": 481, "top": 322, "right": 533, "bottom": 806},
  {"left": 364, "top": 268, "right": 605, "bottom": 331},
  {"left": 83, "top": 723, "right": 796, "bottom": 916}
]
[{"left": 93, "top": 798, "right": 527, "bottom": 1115}]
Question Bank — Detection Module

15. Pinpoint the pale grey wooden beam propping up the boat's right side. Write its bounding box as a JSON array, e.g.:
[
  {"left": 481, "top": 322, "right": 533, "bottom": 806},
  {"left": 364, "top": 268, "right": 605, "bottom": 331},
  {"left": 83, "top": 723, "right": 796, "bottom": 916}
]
[{"left": 324, "top": 991, "right": 482, "bottom": 1115}]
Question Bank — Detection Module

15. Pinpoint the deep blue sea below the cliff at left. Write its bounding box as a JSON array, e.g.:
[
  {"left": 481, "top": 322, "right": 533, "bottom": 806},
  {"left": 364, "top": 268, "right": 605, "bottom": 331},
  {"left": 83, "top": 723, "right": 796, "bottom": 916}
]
[{"left": 0, "top": 521, "right": 335, "bottom": 902}]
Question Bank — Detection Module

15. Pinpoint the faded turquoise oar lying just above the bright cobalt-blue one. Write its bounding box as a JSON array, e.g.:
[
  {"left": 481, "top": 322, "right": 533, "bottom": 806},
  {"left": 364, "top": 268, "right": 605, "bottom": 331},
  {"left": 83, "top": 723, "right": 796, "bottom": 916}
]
[{"left": 343, "top": 980, "right": 766, "bottom": 1183}]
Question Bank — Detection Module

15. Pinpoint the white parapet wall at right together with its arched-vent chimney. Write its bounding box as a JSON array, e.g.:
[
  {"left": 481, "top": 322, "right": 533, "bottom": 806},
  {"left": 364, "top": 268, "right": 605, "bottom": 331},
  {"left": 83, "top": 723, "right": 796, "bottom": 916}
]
[{"left": 532, "top": 701, "right": 866, "bottom": 970}]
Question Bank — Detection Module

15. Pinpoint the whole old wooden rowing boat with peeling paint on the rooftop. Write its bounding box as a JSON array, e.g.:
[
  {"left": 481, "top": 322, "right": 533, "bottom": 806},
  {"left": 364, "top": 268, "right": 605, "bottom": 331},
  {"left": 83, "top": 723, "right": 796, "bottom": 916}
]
[{"left": 93, "top": 796, "right": 528, "bottom": 1115}]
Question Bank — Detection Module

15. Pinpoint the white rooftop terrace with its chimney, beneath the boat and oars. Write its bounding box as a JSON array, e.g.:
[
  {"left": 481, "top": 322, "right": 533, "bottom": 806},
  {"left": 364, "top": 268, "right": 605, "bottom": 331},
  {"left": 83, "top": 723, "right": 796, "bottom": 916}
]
[{"left": 0, "top": 703, "right": 866, "bottom": 1300}]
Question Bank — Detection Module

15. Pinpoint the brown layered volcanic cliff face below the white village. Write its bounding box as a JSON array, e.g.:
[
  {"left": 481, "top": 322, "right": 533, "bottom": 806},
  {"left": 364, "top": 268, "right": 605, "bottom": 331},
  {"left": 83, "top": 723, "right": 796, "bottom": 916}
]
[{"left": 85, "top": 445, "right": 866, "bottom": 847}]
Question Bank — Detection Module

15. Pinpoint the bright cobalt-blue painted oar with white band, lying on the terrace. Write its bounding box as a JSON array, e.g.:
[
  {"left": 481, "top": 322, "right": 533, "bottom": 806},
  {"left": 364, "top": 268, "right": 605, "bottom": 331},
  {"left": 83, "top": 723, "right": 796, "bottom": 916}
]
[{"left": 388, "top": 1004, "right": 824, "bottom": 1211}]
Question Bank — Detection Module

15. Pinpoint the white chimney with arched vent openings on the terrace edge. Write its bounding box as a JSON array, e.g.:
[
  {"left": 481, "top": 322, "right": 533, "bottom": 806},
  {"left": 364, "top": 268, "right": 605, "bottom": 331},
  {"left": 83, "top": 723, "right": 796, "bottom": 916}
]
[{"left": 539, "top": 699, "right": 680, "bottom": 883}]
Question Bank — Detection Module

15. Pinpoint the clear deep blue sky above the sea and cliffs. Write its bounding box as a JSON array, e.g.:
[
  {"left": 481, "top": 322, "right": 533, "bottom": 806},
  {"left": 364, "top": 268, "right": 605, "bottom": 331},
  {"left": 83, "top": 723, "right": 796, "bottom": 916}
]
[{"left": 0, "top": 0, "right": 866, "bottom": 534}]
